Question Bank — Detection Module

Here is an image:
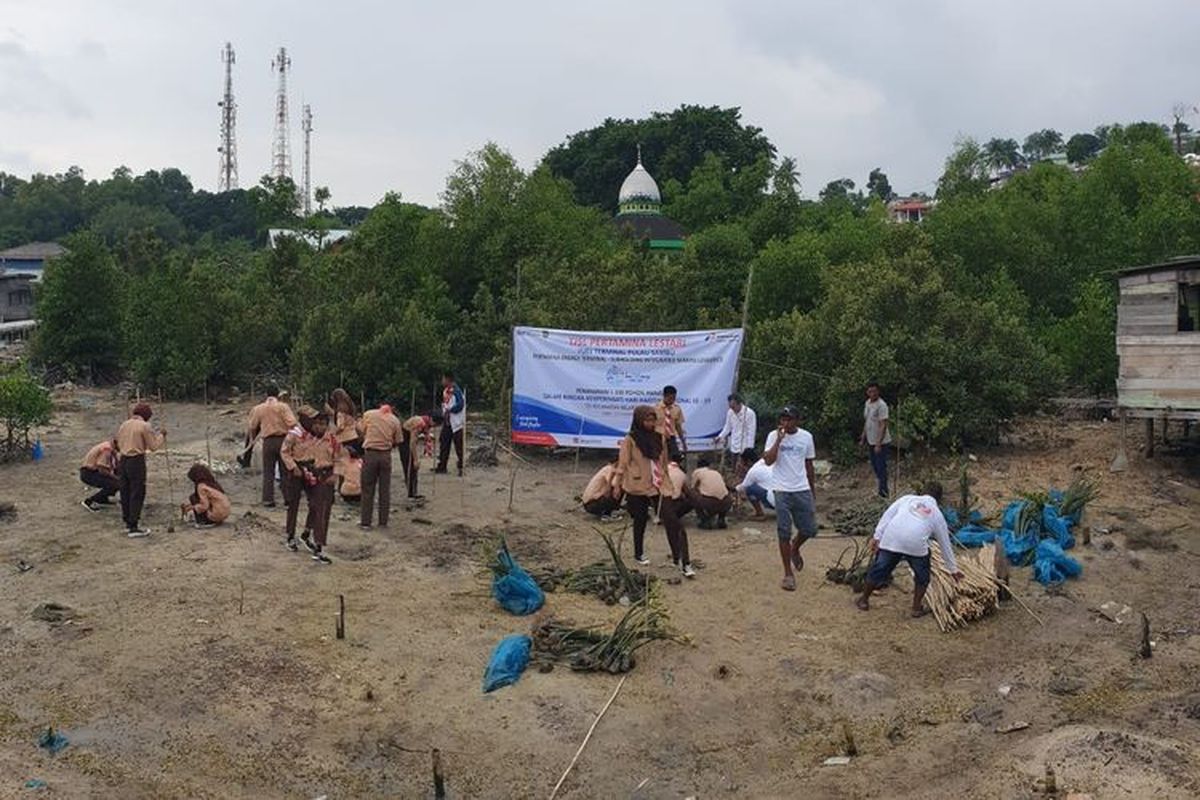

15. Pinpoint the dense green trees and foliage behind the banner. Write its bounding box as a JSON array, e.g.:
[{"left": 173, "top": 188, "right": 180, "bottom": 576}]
[{"left": 16, "top": 107, "right": 1200, "bottom": 443}]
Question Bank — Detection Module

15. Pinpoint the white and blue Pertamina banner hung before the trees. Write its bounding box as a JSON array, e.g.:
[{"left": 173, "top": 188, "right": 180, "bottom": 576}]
[{"left": 512, "top": 327, "right": 742, "bottom": 450}]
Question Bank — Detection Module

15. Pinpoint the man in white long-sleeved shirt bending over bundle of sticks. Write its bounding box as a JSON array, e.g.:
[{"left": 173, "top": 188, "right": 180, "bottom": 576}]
[{"left": 854, "top": 482, "right": 962, "bottom": 616}]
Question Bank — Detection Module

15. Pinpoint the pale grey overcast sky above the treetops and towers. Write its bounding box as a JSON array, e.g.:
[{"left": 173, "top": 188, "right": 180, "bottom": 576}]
[{"left": 0, "top": 0, "right": 1200, "bottom": 205}]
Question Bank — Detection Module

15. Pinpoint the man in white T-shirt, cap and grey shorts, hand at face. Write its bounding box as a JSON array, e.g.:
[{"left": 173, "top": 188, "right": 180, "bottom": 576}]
[{"left": 762, "top": 405, "right": 817, "bottom": 591}]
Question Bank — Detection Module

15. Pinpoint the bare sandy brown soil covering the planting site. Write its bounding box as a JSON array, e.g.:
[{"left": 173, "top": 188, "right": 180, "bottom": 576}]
[{"left": 0, "top": 392, "right": 1200, "bottom": 800}]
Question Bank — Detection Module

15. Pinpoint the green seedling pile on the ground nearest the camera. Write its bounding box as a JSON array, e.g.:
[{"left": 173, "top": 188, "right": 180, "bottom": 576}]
[{"left": 530, "top": 596, "right": 686, "bottom": 674}]
